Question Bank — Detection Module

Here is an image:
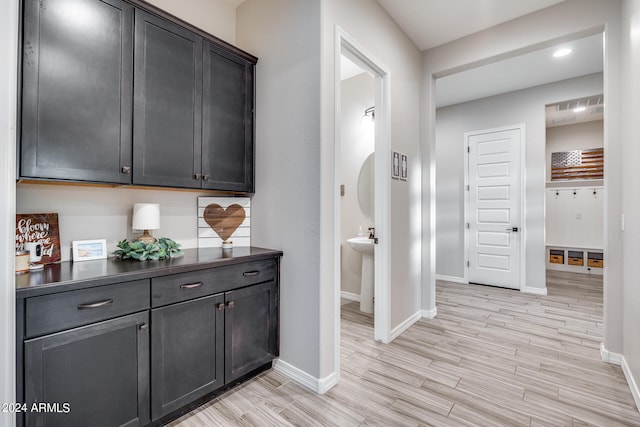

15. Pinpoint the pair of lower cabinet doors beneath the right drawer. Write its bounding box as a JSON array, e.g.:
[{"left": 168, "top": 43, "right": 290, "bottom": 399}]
[{"left": 151, "top": 281, "right": 278, "bottom": 420}]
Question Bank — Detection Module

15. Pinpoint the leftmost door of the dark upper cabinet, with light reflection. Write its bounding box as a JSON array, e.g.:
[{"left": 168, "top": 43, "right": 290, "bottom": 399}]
[{"left": 20, "top": 0, "right": 133, "bottom": 183}]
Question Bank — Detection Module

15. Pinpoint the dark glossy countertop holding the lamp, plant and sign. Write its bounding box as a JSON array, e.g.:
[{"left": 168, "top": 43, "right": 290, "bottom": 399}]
[{"left": 16, "top": 247, "right": 282, "bottom": 299}]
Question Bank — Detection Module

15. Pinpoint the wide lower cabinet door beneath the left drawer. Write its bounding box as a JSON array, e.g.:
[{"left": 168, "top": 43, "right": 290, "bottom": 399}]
[{"left": 24, "top": 312, "right": 149, "bottom": 427}]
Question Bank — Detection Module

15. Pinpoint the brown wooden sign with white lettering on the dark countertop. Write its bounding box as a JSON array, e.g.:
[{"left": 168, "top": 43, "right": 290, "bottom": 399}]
[{"left": 16, "top": 213, "right": 60, "bottom": 264}]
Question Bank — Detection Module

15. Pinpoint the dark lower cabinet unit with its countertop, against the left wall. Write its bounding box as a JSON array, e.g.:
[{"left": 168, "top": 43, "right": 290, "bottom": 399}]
[{"left": 16, "top": 247, "right": 282, "bottom": 426}]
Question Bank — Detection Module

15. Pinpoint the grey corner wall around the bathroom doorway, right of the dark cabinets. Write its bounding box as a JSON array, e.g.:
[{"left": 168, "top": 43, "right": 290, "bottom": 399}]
[{"left": 237, "top": 0, "right": 421, "bottom": 389}]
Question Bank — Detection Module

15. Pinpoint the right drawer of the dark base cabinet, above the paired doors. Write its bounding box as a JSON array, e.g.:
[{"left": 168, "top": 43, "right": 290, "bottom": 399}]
[{"left": 151, "top": 259, "right": 276, "bottom": 307}]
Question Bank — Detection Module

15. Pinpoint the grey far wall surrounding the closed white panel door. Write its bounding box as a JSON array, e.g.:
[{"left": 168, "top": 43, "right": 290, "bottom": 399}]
[{"left": 436, "top": 73, "right": 602, "bottom": 282}]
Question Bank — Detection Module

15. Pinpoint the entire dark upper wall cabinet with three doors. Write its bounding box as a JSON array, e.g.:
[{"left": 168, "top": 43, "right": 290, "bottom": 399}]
[{"left": 19, "top": 0, "right": 257, "bottom": 193}]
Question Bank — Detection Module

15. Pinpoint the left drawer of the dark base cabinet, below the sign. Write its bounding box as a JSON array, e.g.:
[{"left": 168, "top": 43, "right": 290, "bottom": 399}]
[{"left": 26, "top": 280, "right": 149, "bottom": 337}]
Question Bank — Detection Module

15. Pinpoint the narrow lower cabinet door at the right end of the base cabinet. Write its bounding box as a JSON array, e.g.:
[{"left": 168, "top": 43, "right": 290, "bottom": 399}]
[{"left": 225, "top": 281, "right": 278, "bottom": 383}]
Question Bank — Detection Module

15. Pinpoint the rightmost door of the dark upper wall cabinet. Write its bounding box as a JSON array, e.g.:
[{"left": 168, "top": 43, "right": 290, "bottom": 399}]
[{"left": 202, "top": 41, "right": 255, "bottom": 192}]
